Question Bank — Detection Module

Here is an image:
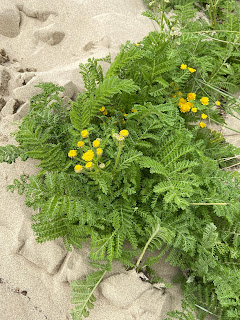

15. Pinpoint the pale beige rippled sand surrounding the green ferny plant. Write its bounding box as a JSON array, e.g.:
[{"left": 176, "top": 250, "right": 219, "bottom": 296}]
[{"left": 0, "top": 0, "right": 240, "bottom": 320}]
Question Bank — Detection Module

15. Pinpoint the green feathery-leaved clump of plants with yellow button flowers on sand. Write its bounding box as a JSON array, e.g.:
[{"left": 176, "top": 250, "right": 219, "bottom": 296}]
[{"left": 0, "top": 1, "right": 240, "bottom": 319}]
